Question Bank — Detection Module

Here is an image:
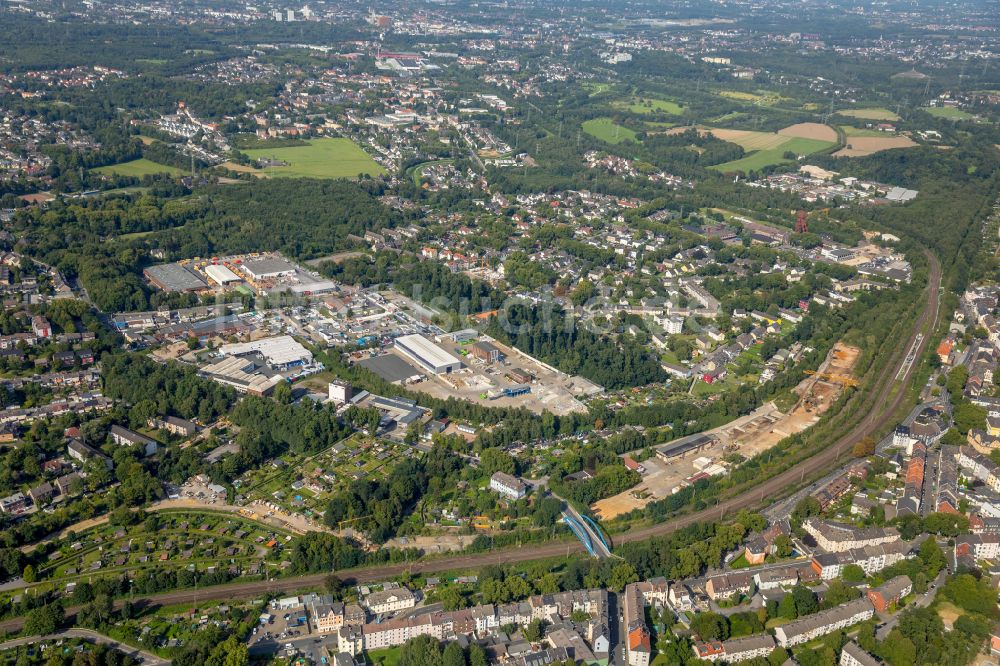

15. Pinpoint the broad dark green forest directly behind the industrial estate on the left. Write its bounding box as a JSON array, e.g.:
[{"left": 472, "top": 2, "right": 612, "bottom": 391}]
[{"left": 14, "top": 179, "right": 403, "bottom": 312}]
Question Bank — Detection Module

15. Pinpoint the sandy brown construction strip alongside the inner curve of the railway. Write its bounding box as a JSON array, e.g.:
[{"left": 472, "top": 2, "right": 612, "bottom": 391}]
[{"left": 591, "top": 343, "right": 861, "bottom": 520}]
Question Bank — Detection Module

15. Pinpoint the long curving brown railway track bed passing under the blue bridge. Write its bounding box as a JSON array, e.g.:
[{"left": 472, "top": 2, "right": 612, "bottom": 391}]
[{"left": 0, "top": 252, "right": 941, "bottom": 631}]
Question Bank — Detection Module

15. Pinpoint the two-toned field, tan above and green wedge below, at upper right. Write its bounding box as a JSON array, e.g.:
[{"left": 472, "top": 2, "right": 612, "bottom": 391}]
[{"left": 711, "top": 123, "right": 837, "bottom": 172}]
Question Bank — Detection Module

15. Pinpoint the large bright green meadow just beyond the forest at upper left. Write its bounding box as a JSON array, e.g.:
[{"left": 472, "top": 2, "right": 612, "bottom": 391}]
[{"left": 243, "top": 137, "right": 385, "bottom": 178}]
